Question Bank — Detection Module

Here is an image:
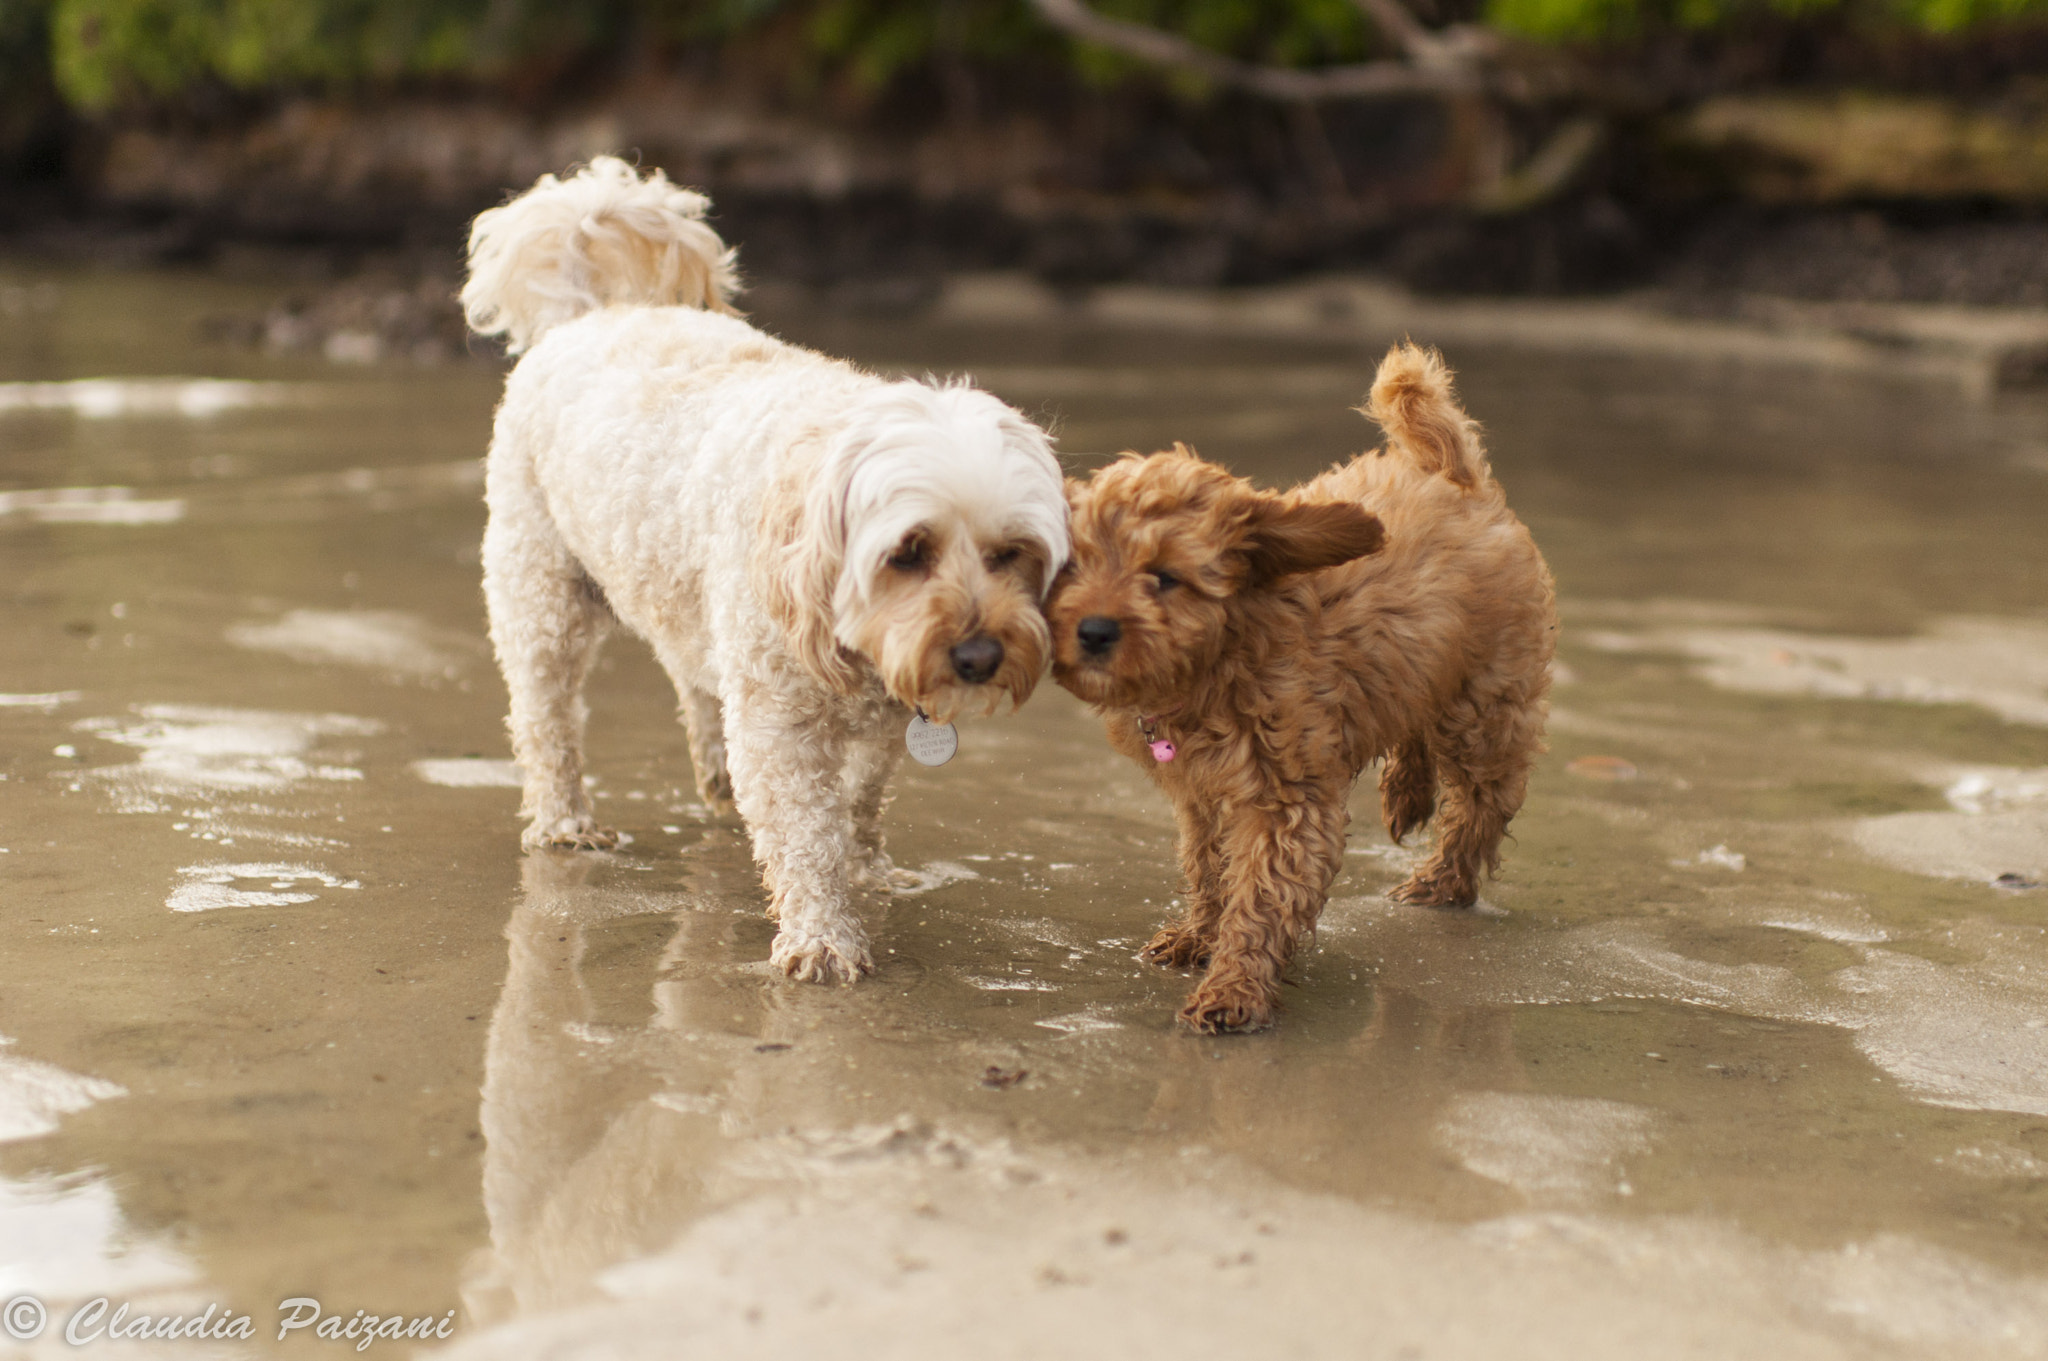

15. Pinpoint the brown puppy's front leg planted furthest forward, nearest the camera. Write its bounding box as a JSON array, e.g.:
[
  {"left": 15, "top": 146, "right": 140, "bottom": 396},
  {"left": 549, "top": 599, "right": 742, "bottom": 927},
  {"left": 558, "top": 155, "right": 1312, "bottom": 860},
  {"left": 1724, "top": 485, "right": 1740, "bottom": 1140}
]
[{"left": 1180, "top": 786, "right": 1348, "bottom": 1036}]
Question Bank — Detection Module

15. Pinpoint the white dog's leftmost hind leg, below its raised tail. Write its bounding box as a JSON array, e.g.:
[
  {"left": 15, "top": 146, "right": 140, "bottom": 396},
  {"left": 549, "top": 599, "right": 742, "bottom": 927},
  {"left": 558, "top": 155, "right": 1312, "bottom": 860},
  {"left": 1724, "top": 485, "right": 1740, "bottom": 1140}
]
[{"left": 483, "top": 497, "right": 618, "bottom": 849}]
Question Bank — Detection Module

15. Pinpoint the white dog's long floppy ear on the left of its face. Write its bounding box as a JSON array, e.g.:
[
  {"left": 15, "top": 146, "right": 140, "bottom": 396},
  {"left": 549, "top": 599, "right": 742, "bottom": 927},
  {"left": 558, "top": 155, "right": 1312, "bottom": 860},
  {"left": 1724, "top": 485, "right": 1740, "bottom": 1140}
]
[{"left": 754, "top": 435, "right": 858, "bottom": 694}]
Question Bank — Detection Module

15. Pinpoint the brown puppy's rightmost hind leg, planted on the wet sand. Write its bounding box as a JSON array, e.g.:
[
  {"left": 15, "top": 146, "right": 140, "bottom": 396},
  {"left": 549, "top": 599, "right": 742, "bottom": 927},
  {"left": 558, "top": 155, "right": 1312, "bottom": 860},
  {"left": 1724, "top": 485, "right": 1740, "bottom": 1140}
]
[{"left": 1386, "top": 704, "right": 1542, "bottom": 907}]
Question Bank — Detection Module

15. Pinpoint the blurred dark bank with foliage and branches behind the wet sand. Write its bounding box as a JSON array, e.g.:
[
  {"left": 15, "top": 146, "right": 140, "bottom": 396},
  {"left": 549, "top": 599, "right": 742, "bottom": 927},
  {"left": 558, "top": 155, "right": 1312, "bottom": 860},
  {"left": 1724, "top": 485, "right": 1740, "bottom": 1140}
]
[{"left": 0, "top": 0, "right": 2048, "bottom": 333}]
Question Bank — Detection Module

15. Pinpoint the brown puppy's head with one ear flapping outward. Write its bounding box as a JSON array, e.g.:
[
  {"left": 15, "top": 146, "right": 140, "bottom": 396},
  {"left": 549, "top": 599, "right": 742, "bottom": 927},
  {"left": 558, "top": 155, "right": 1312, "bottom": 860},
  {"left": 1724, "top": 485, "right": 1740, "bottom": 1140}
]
[{"left": 1044, "top": 444, "right": 1384, "bottom": 708}]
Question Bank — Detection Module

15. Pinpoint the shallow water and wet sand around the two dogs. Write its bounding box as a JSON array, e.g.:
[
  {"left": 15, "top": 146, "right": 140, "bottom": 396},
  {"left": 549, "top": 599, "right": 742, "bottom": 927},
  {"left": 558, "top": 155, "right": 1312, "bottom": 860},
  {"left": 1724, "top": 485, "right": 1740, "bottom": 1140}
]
[{"left": 0, "top": 270, "right": 2048, "bottom": 1357}]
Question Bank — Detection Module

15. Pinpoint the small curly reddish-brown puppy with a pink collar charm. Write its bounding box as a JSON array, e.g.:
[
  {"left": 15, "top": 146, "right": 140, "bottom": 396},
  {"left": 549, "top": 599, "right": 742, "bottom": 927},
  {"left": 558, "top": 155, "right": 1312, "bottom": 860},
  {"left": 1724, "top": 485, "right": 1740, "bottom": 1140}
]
[{"left": 1047, "top": 346, "right": 1556, "bottom": 1034}]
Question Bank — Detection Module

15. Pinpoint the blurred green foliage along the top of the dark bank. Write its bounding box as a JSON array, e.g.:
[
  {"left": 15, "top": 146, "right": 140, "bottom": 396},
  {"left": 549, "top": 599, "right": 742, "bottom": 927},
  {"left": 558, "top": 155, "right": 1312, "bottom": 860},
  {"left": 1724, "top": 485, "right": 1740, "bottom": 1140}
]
[{"left": 24, "top": 0, "right": 2048, "bottom": 108}]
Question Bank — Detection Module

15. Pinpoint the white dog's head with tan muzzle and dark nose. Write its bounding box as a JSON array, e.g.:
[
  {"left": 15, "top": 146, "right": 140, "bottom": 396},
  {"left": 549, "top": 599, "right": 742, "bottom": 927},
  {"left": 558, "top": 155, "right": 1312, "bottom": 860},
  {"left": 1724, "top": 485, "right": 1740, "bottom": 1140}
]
[{"left": 760, "top": 383, "right": 1067, "bottom": 722}]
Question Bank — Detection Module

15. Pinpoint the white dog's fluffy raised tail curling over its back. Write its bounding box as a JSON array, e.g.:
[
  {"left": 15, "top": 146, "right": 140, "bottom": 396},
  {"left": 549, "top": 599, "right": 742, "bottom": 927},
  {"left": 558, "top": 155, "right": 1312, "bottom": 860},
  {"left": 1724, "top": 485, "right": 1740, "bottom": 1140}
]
[{"left": 463, "top": 156, "right": 739, "bottom": 354}]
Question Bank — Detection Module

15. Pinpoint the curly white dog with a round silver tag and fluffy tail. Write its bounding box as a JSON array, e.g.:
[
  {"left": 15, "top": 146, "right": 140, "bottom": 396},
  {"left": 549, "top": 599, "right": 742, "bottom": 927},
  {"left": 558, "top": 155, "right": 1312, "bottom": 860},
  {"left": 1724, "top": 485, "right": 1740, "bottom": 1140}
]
[{"left": 463, "top": 158, "right": 1067, "bottom": 980}]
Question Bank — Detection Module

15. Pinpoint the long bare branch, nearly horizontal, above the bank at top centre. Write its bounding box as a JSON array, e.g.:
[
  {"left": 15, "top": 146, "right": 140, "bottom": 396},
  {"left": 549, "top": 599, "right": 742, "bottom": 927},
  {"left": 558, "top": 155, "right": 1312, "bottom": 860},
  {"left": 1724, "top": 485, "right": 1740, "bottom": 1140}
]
[{"left": 1032, "top": 0, "right": 1481, "bottom": 102}]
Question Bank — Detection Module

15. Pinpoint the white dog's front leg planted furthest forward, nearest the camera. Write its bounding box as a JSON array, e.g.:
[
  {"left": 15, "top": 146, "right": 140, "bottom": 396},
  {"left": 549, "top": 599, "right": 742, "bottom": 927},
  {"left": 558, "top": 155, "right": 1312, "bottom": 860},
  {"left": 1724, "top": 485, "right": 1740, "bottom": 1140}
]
[{"left": 725, "top": 686, "right": 874, "bottom": 982}]
